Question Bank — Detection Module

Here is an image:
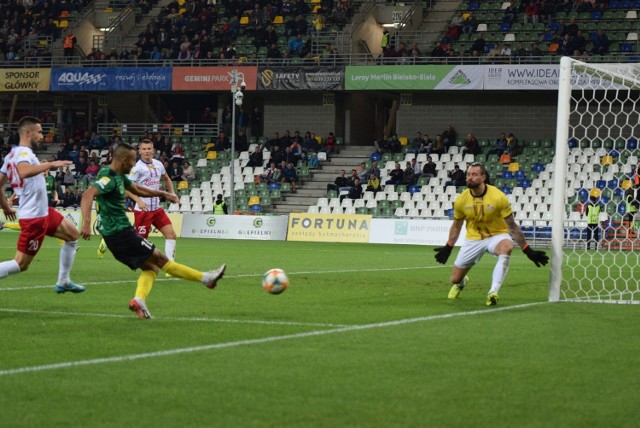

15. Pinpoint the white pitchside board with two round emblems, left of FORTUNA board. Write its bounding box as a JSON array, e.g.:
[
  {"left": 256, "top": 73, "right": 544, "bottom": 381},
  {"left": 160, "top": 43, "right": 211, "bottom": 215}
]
[{"left": 182, "top": 213, "right": 287, "bottom": 241}]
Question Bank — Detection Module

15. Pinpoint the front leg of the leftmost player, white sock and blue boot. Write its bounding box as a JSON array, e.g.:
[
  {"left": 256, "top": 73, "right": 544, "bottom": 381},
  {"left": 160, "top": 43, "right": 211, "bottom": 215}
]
[{"left": 47, "top": 208, "right": 85, "bottom": 293}]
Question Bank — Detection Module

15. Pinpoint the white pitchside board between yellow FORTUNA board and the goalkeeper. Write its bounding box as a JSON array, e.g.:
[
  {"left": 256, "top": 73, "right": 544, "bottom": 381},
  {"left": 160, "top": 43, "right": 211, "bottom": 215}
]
[{"left": 369, "top": 218, "right": 467, "bottom": 246}]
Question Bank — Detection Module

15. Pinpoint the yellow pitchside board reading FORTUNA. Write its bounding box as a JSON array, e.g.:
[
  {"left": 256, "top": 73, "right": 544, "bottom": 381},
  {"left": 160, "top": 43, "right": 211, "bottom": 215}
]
[{"left": 287, "top": 213, "right": 371, "bottom": 242}]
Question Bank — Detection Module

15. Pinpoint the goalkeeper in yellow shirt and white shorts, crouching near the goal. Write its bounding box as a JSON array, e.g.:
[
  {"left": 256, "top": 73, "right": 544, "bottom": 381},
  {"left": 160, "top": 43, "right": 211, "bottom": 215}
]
[{"left": 435, "top": 162, "right": 549, "bottom": 306}]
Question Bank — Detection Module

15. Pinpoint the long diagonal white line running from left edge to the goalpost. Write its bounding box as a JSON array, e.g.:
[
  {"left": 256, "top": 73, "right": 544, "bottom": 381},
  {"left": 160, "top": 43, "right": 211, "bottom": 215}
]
[{"left": 0, "top": 302, "right": 547, "bottom": 376}]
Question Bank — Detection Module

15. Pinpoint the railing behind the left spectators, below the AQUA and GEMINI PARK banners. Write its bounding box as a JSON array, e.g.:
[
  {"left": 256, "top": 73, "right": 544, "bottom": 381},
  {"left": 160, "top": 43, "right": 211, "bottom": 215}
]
[{"left": 98, "top": 123, "right": 220, "bottom": 137}]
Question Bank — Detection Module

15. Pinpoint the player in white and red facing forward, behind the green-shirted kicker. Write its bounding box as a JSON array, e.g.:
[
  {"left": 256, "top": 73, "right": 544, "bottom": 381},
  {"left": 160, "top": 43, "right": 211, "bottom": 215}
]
[{"left": 98, "top": 139, "right": 176, "bottom": 270}]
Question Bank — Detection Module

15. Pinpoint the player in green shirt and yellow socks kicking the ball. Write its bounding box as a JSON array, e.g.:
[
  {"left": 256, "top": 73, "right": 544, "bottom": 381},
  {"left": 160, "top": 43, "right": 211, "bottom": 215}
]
[{"left": 80, "top": 143, "right": 226, "bottom": 318}]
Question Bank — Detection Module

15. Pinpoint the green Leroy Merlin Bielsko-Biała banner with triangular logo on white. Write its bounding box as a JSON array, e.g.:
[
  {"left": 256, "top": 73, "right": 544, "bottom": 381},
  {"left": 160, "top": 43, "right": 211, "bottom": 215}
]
[{"left": 345, "top": 65, "right": 483, "bottom": 91}]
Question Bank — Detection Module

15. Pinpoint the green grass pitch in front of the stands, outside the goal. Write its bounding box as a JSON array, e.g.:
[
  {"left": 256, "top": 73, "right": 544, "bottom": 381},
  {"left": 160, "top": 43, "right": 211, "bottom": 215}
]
[{"left": 0, "top": 231, "right": 640, "bottom": 428}]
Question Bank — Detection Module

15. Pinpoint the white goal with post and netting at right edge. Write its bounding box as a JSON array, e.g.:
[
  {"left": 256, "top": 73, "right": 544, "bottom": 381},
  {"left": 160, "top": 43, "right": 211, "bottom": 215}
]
[{"left": 547, "top": 57, "right": 640, "bottom": 304}]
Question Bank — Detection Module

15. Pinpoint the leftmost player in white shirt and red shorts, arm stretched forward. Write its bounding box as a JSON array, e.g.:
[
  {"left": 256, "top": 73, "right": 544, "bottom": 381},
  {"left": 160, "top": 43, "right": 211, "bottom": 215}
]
[{"left": 0, "top": 116, "right": 85, "bottom": 293}]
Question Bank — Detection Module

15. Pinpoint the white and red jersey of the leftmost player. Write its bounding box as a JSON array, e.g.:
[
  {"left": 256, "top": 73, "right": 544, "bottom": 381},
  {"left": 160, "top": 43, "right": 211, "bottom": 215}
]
[{"left": 0, "top": 146, "right": 49, "bottom": 219}]
